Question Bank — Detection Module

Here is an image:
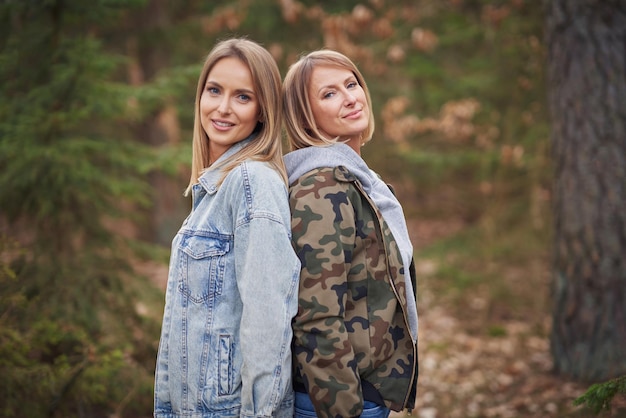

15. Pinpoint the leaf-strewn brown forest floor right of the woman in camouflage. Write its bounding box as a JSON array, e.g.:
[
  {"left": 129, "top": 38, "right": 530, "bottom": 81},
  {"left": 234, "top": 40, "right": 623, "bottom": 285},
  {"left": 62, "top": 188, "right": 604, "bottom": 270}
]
[{"left": 392, "top": 220, "right": 626, "bottom": 418}]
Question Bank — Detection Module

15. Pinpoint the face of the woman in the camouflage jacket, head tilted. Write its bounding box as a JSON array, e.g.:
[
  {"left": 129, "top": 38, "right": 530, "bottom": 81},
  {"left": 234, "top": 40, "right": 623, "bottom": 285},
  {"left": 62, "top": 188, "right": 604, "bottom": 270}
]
[{"left": 309, "top": 65, "right": 370, "bottom": 152}]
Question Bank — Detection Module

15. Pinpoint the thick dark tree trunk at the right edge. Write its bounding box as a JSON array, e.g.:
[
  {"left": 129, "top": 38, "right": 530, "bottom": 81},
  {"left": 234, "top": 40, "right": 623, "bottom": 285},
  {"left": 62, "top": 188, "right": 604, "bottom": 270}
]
[{"left": 545, "top": 0, "right": 626, "bottom": 382}]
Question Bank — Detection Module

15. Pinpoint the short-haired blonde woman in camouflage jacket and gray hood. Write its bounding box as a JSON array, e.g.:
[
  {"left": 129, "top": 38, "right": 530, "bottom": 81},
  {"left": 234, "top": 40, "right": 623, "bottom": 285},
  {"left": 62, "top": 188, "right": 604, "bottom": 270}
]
[{"left": 283, "top": 50, "right": 418, "bottom": 418}]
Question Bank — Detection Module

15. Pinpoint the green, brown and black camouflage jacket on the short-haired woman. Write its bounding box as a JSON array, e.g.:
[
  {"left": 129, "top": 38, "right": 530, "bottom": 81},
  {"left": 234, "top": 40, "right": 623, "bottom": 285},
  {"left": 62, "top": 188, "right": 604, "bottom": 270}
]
[{"left": 289, "top": 167, "right": 417, "bottom": 417}]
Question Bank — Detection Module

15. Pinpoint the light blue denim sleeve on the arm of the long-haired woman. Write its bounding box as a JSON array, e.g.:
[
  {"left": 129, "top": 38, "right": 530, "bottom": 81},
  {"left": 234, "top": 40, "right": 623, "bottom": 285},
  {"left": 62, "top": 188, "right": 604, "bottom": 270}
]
[{"left": 235, "top": 165, "right": 300, "bottom": 417}]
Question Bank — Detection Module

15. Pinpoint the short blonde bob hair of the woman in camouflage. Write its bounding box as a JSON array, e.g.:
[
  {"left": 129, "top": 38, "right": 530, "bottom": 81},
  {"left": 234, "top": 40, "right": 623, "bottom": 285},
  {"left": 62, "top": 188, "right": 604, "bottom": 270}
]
[{"left": 283, "top": 49, "right": 374, "bottom": 151}]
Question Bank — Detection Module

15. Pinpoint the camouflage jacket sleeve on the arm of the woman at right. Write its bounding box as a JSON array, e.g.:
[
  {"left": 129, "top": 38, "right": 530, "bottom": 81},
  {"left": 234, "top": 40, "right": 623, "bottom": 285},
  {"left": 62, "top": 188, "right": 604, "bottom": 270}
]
[{"left": 290, "top": 171, "right": 363, "bottom": 417}]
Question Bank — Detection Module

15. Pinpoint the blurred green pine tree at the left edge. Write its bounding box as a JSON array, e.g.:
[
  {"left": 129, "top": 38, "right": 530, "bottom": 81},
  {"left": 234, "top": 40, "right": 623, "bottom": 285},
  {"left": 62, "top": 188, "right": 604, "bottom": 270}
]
[{"left": 0, "top": 0, "right": 166, "bottom": 418}]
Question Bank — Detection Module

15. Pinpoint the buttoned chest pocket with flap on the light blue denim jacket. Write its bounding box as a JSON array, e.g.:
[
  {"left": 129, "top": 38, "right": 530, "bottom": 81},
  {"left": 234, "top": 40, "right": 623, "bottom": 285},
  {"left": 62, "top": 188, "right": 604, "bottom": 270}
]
[{"left": 178, "top": 235, "right": 231, "bottom": 303}]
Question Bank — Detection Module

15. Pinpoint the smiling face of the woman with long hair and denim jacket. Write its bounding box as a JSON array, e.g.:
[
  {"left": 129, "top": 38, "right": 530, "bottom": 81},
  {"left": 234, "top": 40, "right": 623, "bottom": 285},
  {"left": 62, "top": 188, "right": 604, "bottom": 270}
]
[{"left": 200, "top": 57, "right": 260, "bottom": 163}]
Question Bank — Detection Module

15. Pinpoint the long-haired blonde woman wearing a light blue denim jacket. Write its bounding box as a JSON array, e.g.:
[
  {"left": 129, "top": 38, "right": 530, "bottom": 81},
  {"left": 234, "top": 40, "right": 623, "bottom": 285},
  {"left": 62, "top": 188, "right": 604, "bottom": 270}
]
[{"left": 154, "top": 39, "right": 300, "bottom": 418}]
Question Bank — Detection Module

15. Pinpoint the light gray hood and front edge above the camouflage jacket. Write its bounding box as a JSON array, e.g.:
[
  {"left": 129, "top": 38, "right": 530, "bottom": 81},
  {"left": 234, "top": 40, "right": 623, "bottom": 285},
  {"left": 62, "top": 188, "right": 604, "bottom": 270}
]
[{"left": 285, "top": 143, "right": 418, "bottom": 338}]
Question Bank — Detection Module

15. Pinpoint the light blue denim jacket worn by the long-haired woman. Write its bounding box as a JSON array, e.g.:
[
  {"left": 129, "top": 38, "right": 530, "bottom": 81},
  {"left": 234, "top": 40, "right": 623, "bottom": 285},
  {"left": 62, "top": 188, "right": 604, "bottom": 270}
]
[{"left": 154, "top": 141, "right": 300, "bottom": 418}]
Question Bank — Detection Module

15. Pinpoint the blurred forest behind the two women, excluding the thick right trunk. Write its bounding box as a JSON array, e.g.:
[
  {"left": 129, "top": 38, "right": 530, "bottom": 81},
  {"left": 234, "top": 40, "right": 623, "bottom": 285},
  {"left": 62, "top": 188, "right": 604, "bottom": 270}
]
[{"left": 0, "top": 0, "right": 624, "bottom": 418}]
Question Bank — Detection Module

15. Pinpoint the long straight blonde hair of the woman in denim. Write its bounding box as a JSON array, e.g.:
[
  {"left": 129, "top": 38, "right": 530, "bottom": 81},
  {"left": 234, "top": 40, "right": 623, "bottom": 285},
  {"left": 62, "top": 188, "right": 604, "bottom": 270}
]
[{"left": 185, "top": 38, "right": 287, "bottom": 195}]
